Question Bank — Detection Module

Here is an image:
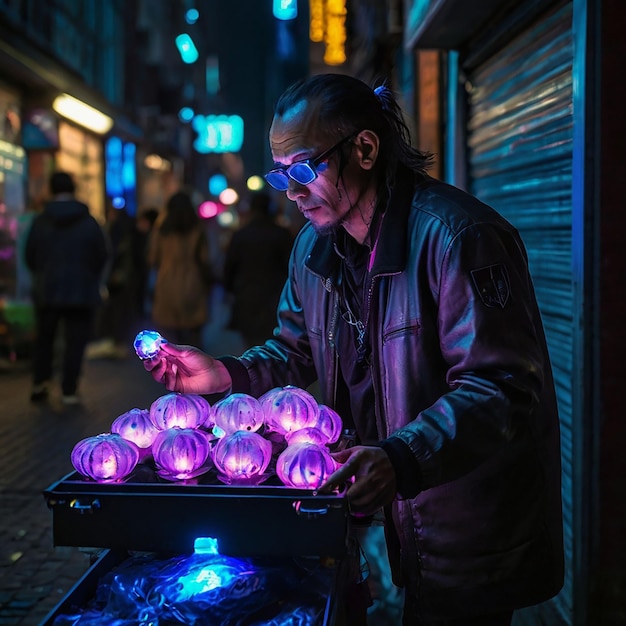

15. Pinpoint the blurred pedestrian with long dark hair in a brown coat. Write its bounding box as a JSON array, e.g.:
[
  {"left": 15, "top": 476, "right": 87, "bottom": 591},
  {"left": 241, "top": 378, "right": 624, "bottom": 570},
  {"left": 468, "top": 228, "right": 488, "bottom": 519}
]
[{"left": 148, "top": 191, "right": 213, "bottom": 345}]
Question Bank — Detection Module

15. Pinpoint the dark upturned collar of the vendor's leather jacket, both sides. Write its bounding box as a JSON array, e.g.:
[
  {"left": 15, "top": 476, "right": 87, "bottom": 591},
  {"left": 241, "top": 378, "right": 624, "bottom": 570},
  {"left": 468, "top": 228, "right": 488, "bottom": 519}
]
[{"left": 305, "top": 168, "right": 415, "bottom": 279}]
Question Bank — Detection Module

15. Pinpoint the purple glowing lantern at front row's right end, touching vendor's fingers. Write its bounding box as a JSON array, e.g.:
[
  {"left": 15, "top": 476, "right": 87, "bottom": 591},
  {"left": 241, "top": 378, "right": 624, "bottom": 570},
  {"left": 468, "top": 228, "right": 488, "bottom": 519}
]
[{"left": 276, "top": 443, "right": 337, "bottom": 489}]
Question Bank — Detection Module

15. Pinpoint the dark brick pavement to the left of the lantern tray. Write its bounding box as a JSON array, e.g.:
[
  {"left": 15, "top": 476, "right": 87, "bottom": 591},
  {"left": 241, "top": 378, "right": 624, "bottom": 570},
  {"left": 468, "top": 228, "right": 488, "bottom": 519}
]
[{"left": 0, "top": 357, "right": 166, "bottom": 626}]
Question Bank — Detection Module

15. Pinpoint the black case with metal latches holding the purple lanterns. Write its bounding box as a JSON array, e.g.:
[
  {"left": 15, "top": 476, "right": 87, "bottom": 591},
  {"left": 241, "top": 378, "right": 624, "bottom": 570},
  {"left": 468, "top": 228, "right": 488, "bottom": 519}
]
[{"left": 44, "top": 472, "right": 350, "bottom": 558}]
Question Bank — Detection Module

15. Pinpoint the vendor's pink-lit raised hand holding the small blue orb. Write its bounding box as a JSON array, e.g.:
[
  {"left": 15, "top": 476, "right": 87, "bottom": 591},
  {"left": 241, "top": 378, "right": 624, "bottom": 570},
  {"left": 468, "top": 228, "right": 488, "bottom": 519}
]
[{"left": 143, "top": 343, "right": 232, "bottom": 394}]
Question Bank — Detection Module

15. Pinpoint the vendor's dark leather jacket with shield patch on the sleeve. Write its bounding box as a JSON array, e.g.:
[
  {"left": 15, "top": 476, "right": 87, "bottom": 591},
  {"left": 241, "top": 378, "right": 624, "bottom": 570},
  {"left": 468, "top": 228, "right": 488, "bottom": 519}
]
[{"left": 224, "top": 177, "right": 563, "bottom": 619}]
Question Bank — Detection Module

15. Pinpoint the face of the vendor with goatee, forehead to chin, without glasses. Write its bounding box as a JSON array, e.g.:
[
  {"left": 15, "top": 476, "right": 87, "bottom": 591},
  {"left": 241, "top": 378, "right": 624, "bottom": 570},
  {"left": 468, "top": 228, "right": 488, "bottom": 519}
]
[{"left": 270, "top": 102, "right": 368, "bottom": 234}]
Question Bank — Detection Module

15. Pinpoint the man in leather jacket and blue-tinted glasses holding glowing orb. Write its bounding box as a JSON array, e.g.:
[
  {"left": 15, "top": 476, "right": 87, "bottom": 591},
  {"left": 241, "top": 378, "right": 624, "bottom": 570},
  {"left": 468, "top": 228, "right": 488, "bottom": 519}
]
[{"left": 145, "top": 75, "right": 563, "bottom": 626}]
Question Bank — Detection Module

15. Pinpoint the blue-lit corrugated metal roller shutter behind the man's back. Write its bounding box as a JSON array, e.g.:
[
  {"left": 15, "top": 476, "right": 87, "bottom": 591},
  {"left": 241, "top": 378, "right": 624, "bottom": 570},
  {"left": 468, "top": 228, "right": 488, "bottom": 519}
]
[{"left": 468, "top": 3, "right": 576, "bottom": 626}]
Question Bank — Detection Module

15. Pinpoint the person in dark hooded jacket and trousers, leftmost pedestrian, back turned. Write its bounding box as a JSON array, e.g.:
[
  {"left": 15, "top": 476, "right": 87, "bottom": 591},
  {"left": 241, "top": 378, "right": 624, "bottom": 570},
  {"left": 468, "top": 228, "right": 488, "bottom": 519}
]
[{"left": 25, "top": 172, "right": 108, "bottom": 404}]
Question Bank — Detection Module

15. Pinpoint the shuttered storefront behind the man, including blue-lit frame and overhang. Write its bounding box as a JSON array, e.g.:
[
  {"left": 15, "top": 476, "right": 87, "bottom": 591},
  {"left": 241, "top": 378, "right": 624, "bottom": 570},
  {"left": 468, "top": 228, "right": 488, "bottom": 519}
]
[{"left": 405, "top": 0, "right": 584, "bottom": 625}]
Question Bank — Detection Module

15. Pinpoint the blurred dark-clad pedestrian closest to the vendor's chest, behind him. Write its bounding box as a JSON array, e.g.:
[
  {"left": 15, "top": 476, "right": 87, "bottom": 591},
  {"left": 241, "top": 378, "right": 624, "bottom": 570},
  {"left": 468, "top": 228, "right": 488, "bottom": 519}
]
[{"left": 224, "top": 191, "right": 293, "bottom": 347}]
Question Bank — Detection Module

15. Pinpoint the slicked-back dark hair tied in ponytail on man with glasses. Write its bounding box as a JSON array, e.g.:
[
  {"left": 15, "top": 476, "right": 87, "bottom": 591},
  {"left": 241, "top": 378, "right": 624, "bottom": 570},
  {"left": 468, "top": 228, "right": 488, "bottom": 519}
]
[{"left": 274, "top": 74, "right": 433, "bottom": 190}]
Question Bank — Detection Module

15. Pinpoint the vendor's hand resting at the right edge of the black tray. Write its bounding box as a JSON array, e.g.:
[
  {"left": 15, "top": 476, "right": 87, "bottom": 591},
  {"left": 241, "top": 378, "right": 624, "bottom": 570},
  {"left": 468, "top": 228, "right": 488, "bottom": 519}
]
[{"left": 319, "top": 446, "right": 397, "bottom": 516}]
